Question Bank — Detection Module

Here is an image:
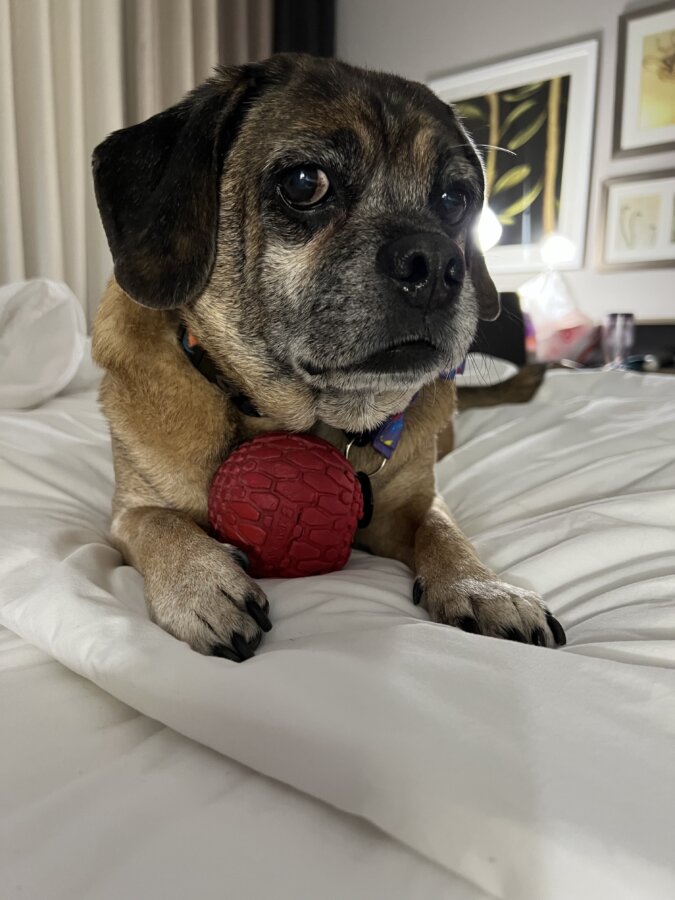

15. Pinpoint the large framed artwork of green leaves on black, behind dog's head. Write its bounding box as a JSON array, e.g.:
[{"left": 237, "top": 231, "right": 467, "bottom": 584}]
[{"left": 429, "top": 40, "right": 598, "bottom": 273}]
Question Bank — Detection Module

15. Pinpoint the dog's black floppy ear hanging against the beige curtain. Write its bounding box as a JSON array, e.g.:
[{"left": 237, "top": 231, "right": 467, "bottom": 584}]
[{"left": 92, "top": 65, "right": 263, "bottom": 309}]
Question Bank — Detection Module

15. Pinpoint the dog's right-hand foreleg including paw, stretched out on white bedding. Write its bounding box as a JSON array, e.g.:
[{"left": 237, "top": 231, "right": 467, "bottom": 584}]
[{"left": 359, "top": 465, "right": 565, "bottom": 647}]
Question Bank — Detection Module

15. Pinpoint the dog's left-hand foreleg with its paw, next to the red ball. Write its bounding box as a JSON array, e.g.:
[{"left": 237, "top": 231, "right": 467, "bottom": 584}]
[{"left": 112, "top": 507, "right": 272, "bottom": 662}]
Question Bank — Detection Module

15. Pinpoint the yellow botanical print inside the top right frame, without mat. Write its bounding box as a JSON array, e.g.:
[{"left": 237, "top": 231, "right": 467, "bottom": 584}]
[{"left": 639, "top": 29, "right": 675, "bottom": 129}]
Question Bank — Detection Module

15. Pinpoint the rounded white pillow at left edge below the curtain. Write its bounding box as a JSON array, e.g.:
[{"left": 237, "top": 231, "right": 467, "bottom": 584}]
[{"left": 0, "top": 278, "right": 87, "bottom": 409}]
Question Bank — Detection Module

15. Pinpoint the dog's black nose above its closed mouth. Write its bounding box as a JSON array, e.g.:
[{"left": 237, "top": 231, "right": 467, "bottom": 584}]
[{"left": 377, "top": 232, "right": 465, "bottom": 308}]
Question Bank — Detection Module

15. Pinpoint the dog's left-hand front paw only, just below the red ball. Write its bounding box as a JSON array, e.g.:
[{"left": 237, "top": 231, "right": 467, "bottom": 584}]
[{"left": 145, "top": 537, "right": 272, "bottom": 662}]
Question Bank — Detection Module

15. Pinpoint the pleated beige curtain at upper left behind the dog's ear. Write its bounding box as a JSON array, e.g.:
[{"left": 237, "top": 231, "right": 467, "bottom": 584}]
[{"left": 0, "top": 0, "right": 272, "bottom": 322}]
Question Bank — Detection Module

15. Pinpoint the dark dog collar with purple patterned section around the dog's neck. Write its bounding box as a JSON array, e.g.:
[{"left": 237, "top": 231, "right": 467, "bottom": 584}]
[{"left": 178, "top": 326, "right": 466, "bottom": 460}]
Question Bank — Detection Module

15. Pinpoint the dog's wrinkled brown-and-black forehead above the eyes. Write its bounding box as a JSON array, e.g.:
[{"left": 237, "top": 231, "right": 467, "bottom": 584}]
[{"left": 248, "top": 66, "right": 483, "bottom": 205}]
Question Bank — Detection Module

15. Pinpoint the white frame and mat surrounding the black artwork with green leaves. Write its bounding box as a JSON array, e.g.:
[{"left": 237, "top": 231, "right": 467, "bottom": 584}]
[{"left": 428, "top": 39, "right": 598, "bottom": 274}]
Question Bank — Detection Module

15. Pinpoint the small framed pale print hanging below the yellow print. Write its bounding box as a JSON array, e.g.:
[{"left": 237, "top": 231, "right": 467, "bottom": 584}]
[{"left": 599, "top": 169, "right": 675, "bottom": 269}]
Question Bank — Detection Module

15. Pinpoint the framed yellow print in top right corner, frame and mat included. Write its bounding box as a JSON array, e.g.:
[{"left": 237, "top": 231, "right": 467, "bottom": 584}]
[{"left": 614, "top": 2, "right": 675, "bottom": 156}]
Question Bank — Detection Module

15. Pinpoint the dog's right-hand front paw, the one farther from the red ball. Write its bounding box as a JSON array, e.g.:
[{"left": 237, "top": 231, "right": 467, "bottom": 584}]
[{"left": 413, "top": 577, "right": 566, "bottom": 647}]
